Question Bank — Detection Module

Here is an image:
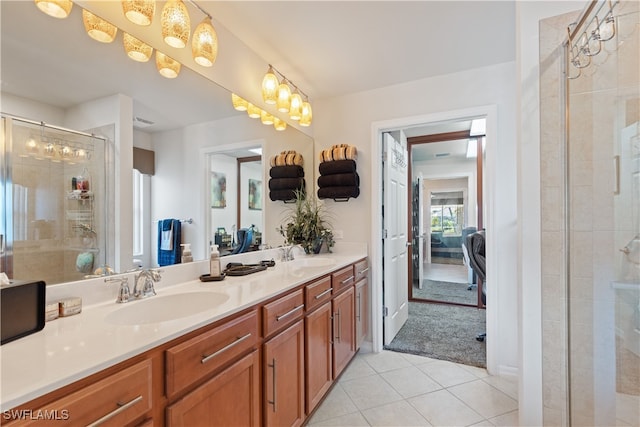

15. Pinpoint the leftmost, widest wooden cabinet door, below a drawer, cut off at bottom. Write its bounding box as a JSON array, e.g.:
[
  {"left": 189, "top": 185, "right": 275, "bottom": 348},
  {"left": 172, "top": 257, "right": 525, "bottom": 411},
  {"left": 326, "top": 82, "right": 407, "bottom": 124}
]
[{"left": 167, "top": 350, "right": 260, "bottom": 427}]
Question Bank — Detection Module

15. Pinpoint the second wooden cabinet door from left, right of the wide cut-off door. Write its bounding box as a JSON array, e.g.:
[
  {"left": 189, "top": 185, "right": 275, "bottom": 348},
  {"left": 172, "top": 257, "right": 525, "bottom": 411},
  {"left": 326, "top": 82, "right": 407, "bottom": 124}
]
[{"left": 263, "top": 319, "right": 304, "bottom": 427}]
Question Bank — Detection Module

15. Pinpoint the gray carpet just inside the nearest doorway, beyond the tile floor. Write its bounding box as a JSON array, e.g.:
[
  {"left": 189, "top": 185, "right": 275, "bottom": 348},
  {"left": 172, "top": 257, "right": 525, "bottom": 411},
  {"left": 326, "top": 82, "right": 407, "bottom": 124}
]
[{"left": 385, "top": 302, "right": 489, "bottom": 368}]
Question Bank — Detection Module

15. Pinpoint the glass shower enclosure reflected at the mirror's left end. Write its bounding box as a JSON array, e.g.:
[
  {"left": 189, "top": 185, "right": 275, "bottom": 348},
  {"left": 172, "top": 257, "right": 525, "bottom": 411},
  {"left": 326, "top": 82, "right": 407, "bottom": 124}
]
[{"left": 1, "top": 118, "right": 106, "bottom": 285}]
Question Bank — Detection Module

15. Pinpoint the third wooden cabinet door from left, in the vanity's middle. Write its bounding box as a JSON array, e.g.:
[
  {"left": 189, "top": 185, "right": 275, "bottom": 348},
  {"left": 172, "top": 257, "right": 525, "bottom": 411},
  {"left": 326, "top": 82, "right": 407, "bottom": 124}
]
[{"left": 304, "top": 301, "right": 333, "bottom": 414}]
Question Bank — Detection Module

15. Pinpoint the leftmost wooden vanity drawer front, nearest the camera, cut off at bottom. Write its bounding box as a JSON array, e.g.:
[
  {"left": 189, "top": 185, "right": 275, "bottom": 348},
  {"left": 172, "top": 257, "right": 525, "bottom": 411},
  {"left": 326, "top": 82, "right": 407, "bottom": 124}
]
[{"left": 7, "top": 360, "right": 152, "bottom": 426}]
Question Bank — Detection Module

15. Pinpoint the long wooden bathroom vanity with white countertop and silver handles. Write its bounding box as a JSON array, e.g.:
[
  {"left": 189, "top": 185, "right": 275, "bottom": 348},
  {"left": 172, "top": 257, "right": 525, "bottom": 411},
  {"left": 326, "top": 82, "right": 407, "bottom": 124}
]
[{"left": 2, "top": 251, "right": 368, "bottom": 426}]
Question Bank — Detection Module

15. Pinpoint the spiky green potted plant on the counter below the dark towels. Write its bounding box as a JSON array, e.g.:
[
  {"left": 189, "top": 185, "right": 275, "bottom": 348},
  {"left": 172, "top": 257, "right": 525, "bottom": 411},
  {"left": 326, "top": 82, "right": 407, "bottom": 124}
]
[{"left": 278, "top": 190, "right": 335, "bottom": 254}]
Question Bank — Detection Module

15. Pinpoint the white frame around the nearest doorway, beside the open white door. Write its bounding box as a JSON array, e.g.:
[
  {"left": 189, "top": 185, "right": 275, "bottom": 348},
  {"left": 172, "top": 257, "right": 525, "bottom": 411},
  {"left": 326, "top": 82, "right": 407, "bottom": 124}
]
[{"left": 371, "top": 104, "right": 501, "bottom": 374}]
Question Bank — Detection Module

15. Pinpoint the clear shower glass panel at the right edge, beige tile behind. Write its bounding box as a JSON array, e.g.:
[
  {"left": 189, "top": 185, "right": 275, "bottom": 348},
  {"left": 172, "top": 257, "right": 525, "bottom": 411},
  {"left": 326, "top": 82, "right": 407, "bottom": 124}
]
[{"left": 566, "top": 1, "right": 640, "bottom": 426}]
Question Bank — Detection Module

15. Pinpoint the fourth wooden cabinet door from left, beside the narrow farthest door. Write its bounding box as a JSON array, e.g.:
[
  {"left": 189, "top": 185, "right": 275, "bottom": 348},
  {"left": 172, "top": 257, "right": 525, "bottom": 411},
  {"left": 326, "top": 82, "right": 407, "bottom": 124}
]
[{"left": 333, "top": 286, "right": 356, "bottom": 378}]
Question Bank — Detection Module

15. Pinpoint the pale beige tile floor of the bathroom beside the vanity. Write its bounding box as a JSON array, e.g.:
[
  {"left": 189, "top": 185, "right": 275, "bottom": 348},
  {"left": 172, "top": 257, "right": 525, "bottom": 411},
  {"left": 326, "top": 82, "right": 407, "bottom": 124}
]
[{"left": 308, "top": 351, "right": 518, "bottom": 427}]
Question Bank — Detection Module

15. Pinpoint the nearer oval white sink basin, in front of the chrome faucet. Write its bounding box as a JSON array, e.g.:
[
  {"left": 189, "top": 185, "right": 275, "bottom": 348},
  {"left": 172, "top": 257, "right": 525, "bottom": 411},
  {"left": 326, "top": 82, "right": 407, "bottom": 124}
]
[{"left": 105, "top": 292, "right": 229, "bottom": 325}]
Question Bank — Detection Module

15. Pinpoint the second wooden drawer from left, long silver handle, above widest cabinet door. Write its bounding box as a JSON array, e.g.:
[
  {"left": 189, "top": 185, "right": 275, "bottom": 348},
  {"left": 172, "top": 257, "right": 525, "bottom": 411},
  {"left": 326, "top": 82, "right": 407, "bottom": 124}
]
[{"left": 166, "top": 311, "right": 259, "bottom": 397}]
